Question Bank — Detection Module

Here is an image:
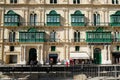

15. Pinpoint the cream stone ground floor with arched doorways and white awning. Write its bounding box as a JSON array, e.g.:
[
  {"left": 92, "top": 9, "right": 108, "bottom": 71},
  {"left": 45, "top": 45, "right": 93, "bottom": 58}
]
[{"left": 4, "top": 44, "right": 120, "bottom": 64}]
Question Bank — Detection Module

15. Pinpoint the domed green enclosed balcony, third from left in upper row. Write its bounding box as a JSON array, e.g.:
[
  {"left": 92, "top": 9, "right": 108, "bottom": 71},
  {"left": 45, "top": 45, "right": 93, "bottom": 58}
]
[{"left": 71, "top": 10, "right": 85, "bottom": 26}]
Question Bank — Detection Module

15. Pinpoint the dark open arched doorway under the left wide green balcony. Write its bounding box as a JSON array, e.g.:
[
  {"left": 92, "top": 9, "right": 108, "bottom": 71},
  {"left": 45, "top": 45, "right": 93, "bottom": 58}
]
[{"left": 28, "top": 48, "right": 37, "bottom": 64}]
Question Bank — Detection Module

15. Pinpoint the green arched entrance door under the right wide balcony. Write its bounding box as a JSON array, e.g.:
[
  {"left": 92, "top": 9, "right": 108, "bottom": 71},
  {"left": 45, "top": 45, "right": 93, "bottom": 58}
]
[{"left": 94, "top": 48, "right": 101, "bottom": 64}]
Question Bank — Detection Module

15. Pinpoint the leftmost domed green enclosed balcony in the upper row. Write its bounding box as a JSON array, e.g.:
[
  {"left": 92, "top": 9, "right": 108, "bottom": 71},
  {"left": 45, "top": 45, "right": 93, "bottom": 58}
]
[{"left": 4, "top": 10, "right": 20, "bottom": 26}]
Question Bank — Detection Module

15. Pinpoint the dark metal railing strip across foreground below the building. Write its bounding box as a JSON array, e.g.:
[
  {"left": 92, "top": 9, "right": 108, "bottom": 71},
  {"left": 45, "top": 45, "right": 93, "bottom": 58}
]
[{"left": 0, "top": 64, "right": 120, "bottom": 80}]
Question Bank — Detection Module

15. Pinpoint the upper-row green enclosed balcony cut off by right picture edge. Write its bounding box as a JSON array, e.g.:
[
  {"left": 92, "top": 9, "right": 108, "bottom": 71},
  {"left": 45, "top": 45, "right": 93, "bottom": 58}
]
[{"left": 110, "top": 11, "right": 120, "bottom": 26}]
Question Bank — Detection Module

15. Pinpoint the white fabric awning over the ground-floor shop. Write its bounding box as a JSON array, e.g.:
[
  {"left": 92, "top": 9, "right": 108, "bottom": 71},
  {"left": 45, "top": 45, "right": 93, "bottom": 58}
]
[{"left": 70, "top": 52, "right": 90, "bottom": 59}]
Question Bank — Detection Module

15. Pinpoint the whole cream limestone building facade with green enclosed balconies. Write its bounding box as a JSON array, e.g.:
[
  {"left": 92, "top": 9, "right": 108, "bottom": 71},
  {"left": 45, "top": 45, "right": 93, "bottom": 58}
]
[{"left": 0, "top": 0, "right": 120, "bottom": 64}]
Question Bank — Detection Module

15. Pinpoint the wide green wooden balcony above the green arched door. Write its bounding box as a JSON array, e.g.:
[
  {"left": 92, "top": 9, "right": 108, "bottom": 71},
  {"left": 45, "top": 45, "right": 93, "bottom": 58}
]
[{"left": 86, "top": 27, "right": 112, "bottom": 43}]
